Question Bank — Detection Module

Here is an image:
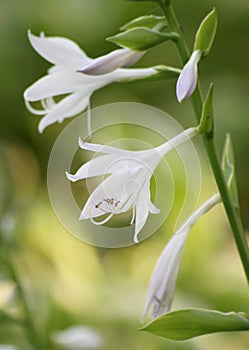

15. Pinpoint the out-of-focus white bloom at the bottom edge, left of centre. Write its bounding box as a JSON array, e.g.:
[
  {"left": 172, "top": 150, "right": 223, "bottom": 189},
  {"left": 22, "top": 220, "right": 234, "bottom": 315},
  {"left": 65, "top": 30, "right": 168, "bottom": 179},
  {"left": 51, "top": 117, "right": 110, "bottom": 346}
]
[{"left": 51, "top": 325, "right": 103, "bottom": 350}]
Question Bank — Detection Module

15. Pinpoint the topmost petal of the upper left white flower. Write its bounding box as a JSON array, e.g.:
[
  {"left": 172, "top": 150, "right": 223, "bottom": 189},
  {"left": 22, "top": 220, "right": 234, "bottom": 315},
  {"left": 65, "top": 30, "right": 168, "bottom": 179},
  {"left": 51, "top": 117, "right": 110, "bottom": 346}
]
[{"left": 28, "top": 30, "right": 91, "bottom": 70}]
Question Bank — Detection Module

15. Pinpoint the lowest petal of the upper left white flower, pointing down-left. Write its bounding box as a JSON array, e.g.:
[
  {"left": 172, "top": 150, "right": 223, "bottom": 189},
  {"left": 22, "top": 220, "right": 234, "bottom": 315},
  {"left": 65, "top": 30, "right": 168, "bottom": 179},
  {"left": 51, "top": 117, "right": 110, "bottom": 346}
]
[{"left": 38, "top": 92, "right": 90, "bottom": 133}]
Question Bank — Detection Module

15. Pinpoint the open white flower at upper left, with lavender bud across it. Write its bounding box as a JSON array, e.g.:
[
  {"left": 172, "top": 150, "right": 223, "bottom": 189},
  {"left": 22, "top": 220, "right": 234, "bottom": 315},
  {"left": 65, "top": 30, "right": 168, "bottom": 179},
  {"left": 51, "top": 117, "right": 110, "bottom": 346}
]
[{"left": 24, "top": 31, "right": 152, "bottom": 132}]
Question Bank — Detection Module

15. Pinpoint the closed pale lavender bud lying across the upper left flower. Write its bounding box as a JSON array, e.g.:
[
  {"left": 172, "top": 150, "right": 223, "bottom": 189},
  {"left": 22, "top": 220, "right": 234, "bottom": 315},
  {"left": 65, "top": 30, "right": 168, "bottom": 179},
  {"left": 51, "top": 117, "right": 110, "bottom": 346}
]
[{"left": 79, "top": 49, "right": 144, "bottom": 75}]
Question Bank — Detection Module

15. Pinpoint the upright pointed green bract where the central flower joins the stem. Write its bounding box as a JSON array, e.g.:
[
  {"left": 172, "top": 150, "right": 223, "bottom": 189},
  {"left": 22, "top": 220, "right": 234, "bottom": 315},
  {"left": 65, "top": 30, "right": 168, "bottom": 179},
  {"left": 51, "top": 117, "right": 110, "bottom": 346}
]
[{"left": 198, "top": 83, "right": 214, "bottom": 137}]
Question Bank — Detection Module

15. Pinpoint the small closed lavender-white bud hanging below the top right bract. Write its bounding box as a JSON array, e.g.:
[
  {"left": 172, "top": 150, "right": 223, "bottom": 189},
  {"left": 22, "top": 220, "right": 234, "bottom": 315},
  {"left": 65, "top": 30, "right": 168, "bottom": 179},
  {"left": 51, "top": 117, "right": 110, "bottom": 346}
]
[{"left": 176, "top": 50, "right": 202, "bottom": 102}]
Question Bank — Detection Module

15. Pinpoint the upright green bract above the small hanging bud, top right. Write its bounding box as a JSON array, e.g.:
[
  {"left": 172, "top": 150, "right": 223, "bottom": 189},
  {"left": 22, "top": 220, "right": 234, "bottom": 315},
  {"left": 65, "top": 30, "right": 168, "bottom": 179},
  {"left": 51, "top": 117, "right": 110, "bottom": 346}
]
[{"left": 194, "top": 9, "right": 217, "bottom": 56}]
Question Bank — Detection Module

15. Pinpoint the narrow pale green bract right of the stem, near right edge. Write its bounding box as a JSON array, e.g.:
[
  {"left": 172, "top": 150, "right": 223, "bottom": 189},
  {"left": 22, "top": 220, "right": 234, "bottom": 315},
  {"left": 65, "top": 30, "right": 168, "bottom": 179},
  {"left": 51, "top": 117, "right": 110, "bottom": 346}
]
[{"left": 222, "top": 134, "right": 239, "bottom": 209}]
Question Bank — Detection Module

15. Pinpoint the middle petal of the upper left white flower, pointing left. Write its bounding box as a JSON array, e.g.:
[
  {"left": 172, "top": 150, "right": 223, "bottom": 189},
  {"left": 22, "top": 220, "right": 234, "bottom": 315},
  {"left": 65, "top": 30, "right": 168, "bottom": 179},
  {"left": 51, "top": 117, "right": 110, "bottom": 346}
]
[{"left": 24, "top": 71, "right": 96, "bottom": 102}]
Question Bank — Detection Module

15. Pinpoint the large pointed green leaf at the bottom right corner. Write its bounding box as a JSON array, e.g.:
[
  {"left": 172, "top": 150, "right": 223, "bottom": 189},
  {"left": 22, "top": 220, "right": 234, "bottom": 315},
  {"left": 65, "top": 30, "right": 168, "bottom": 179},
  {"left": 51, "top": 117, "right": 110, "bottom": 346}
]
[{"left": 140, "top": 309, "right": 249, "bottom": 340}]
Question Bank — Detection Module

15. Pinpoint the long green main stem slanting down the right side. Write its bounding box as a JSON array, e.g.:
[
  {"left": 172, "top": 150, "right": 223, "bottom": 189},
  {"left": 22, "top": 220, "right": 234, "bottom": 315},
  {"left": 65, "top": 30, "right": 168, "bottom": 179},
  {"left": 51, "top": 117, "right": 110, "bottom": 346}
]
[{"left": 162, "top": 2, "right": 249, "bottom": 282}]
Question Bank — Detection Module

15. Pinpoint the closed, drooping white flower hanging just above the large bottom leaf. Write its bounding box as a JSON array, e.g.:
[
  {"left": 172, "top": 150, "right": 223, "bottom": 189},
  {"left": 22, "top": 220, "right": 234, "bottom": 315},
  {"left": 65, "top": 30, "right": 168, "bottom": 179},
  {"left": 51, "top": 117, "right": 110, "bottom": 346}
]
[{"left": 142, "top": 194, "right": 220, "bottom": 320}]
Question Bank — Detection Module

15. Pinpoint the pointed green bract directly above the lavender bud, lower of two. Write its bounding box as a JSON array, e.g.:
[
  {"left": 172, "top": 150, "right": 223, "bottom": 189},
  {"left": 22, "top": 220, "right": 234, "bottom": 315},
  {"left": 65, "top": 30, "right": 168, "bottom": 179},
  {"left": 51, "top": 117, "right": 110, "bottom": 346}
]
[{"left": 106, "top": 27, "right": 178, "bottom": 51}]
